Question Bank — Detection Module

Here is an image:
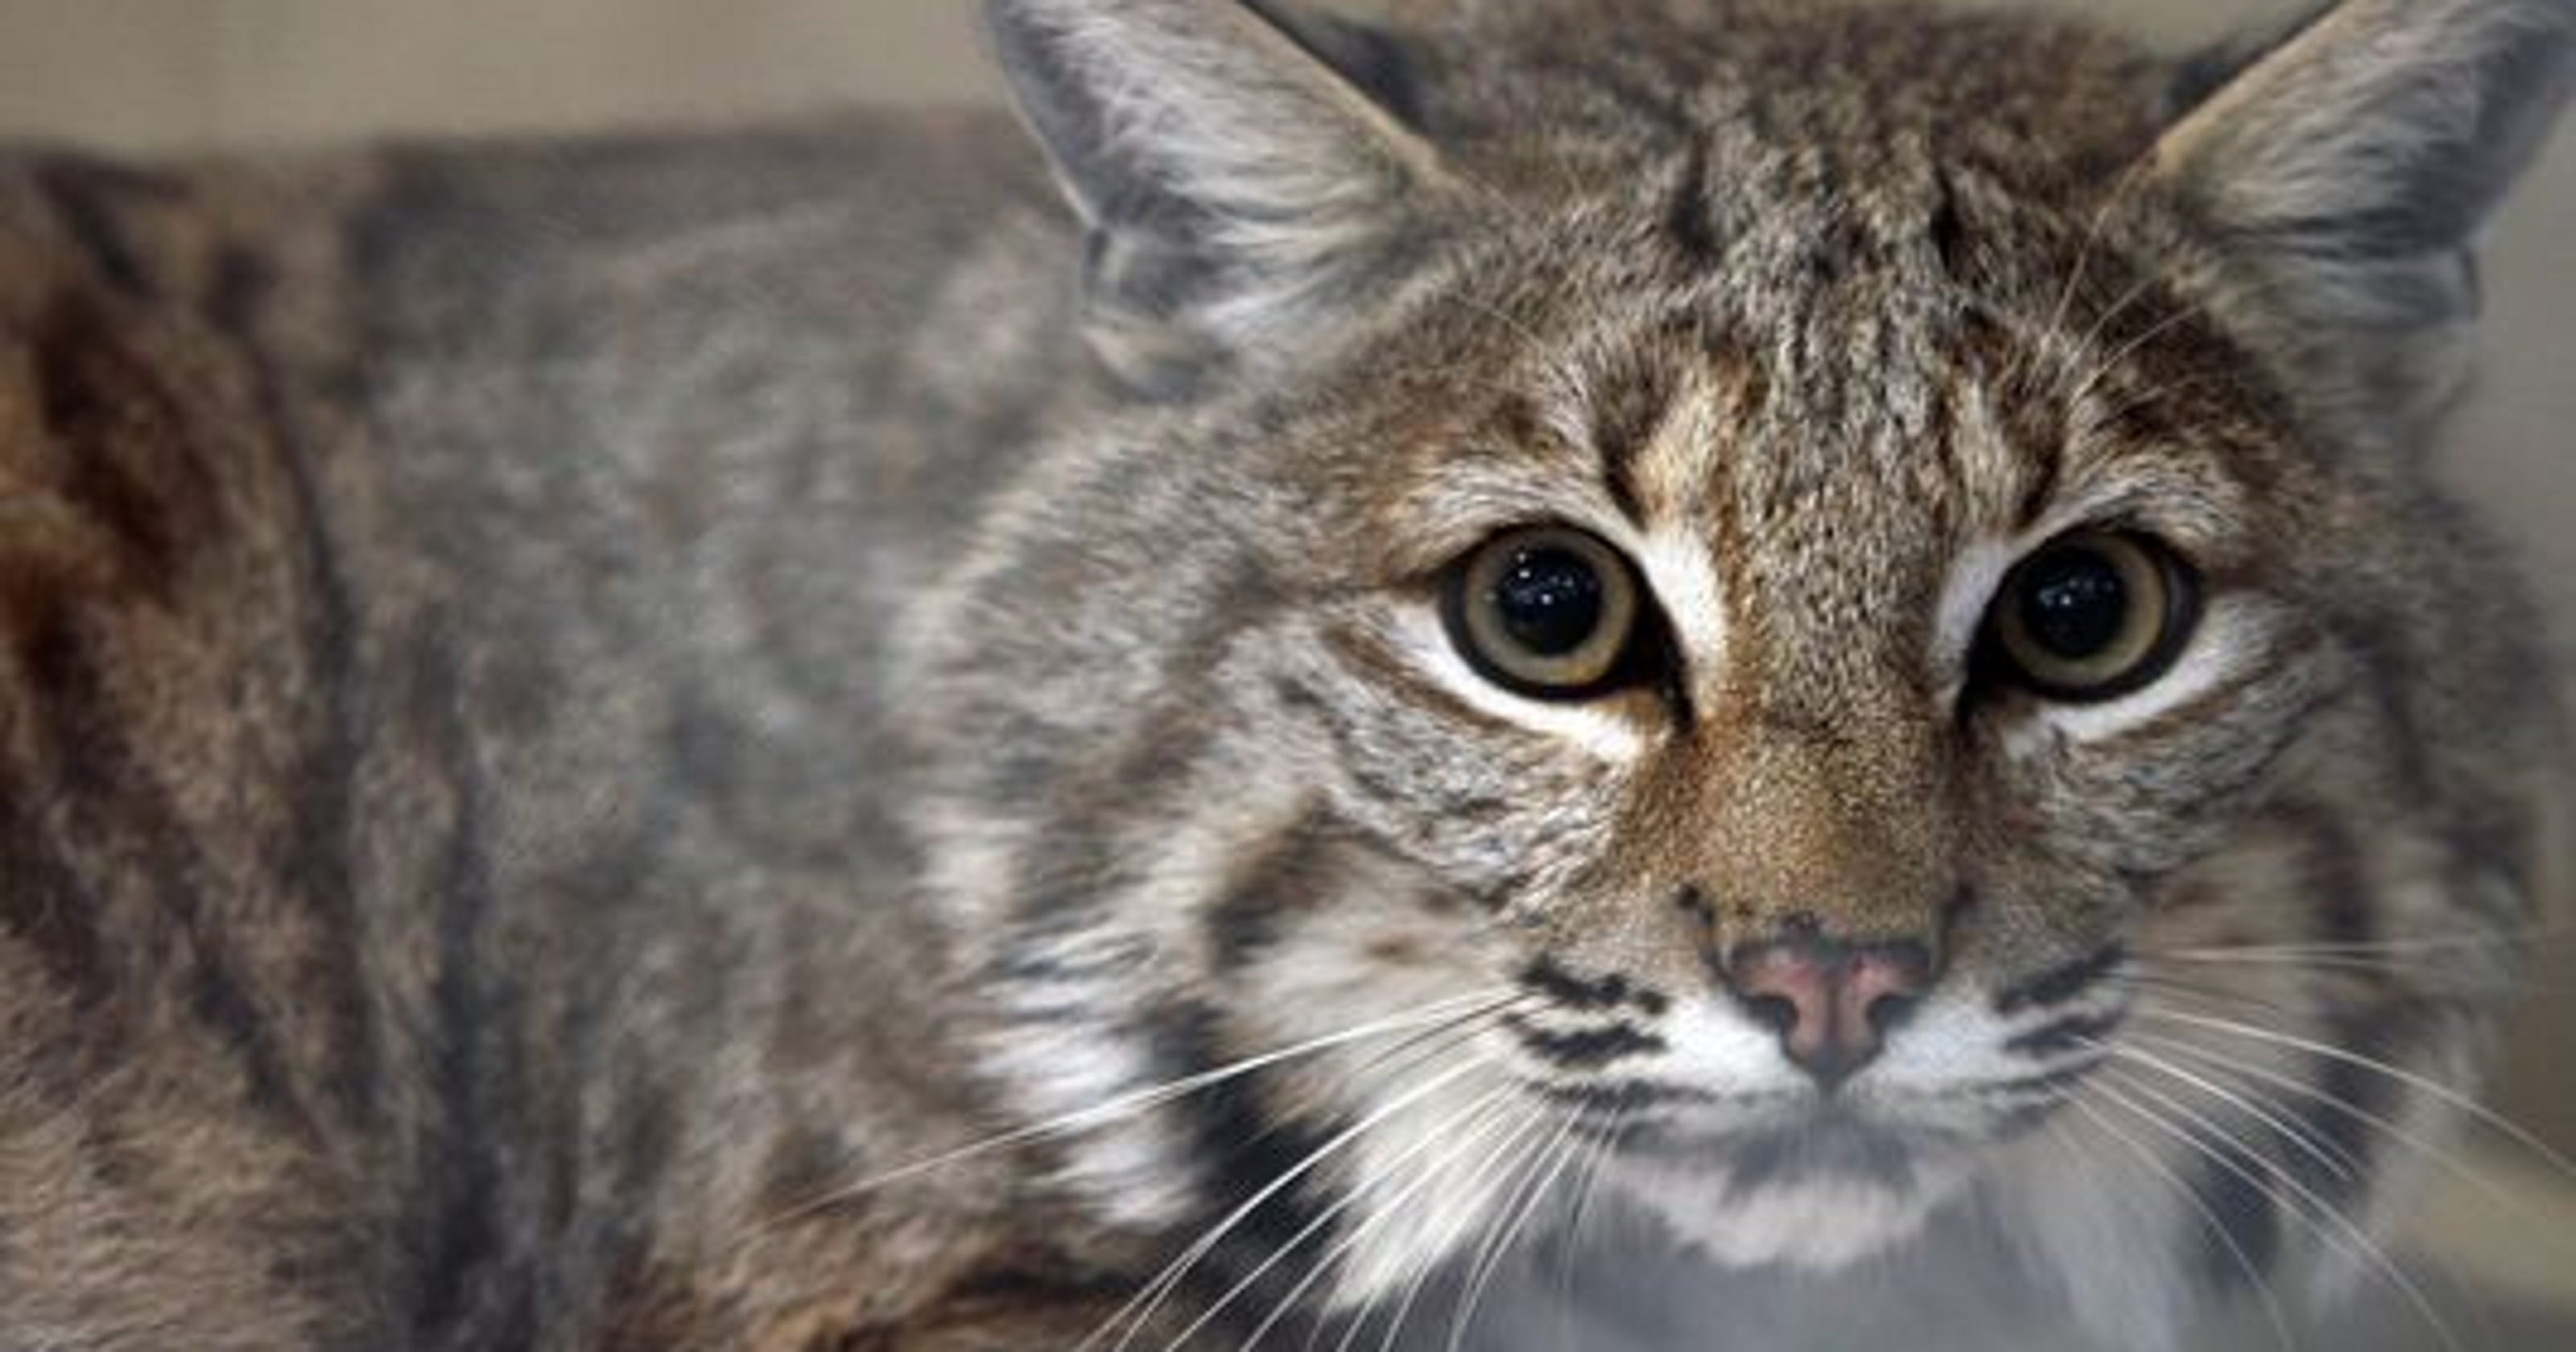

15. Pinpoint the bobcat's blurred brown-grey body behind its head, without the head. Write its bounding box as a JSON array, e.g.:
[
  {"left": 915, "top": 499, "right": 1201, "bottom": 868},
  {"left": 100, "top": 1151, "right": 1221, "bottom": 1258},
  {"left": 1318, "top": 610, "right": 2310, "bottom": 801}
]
[{"left": 0, "top": 116, "right": 1116, "bottom": 1350}]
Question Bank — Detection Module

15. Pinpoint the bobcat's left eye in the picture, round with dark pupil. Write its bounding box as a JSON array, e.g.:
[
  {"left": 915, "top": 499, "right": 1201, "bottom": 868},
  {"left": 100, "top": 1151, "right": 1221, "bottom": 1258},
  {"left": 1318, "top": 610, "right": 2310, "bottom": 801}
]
[{"left": 1445, "top": 526, "right": 1638, "bottom": 700}]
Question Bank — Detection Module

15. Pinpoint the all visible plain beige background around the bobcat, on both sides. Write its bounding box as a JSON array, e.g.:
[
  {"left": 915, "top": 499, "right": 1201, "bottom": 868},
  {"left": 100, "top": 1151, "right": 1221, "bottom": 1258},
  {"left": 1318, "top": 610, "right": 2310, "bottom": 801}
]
[{"left": 0, "top": 0, "right": 2576, "bottom": 1297}]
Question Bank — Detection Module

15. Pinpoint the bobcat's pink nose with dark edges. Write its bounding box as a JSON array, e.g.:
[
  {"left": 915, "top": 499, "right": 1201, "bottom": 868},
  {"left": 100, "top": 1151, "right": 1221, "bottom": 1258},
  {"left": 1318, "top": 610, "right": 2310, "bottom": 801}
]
[{"left": 1726, "top": 935, "right": 1934, "bottom": 1092}]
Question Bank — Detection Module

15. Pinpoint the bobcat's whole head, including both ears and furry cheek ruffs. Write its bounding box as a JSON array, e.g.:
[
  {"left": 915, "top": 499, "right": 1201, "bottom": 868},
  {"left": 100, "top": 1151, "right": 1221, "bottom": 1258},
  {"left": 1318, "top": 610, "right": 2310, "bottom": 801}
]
[{"left": 943, "top": 0, "right": 2563, "bottom": 1337}]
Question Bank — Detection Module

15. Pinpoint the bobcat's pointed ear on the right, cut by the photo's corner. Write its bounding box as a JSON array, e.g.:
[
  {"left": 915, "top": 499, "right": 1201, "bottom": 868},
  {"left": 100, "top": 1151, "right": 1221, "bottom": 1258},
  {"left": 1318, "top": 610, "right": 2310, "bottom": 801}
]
[{"left": 2151, "top": 0, "right": 2576, "bottom": 440}]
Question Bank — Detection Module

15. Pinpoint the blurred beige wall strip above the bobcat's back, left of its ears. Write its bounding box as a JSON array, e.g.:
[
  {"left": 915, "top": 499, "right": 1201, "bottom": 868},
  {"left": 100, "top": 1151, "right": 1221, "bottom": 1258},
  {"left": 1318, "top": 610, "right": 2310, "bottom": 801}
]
[{"left": 0, "top": 0, "right": 997, "bottom": 150}]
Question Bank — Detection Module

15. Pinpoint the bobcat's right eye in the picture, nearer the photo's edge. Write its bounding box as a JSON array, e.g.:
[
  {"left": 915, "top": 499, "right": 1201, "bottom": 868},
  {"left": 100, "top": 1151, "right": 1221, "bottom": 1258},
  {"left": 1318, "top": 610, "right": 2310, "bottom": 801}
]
[{"left": 1986, "top": 530, "right": 2200, "bottom": 700}]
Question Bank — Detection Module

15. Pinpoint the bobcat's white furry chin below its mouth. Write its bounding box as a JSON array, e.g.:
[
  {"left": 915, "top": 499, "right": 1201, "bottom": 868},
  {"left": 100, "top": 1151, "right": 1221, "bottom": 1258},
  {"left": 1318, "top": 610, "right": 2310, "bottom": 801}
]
[{"left": 1605, "top": 1125, "right": 1971, "bottom": 1272}]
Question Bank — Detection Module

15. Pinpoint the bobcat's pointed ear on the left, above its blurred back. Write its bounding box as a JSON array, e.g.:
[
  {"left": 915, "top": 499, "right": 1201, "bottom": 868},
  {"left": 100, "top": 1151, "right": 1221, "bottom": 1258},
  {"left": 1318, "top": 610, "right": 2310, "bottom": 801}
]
[{"left": 984, "top": 0, "right": 1447, "bottom": 397}]
